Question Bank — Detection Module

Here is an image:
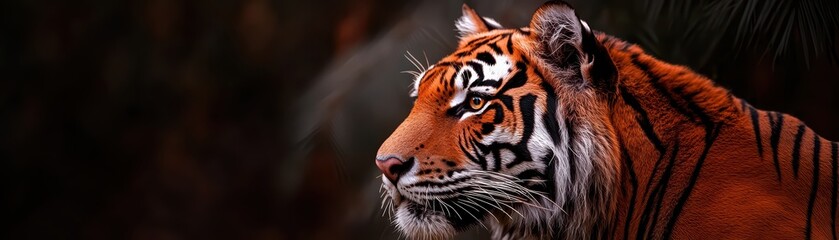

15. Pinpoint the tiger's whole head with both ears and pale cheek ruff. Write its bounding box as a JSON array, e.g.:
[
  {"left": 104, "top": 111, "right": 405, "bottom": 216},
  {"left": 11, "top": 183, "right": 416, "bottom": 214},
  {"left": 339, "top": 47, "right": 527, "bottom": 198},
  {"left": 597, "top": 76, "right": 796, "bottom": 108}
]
[{"left": 375, "top": 2, "right": 618, "bottom": 239}]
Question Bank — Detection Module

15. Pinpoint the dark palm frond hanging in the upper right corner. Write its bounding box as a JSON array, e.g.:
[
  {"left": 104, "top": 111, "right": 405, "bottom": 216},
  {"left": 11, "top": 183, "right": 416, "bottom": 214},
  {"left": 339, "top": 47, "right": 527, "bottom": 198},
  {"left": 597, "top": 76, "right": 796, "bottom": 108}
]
[{"left": 644, "top": 0, "right": 839, "bottom": 66}]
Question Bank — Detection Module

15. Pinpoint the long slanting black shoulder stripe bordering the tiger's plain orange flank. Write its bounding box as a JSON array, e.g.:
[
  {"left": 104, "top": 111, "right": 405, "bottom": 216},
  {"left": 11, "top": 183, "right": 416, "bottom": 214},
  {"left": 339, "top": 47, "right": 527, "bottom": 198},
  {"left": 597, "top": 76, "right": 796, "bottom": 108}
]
[{"left": 661, "top": 125, "right": 720, "bottom": 239}]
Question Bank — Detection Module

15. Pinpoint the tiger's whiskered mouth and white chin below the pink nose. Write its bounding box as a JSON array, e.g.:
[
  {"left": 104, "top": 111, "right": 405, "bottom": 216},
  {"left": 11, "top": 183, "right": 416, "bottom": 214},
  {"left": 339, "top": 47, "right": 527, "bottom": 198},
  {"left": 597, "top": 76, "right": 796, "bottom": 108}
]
[{"left": 382, "top": 172, "right": 552, "bottom": 238}]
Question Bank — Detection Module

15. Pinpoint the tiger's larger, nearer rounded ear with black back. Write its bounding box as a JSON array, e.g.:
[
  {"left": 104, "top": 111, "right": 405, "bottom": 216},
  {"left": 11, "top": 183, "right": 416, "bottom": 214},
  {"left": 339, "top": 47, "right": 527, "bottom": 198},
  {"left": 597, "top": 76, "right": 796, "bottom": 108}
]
[{"left": 530, "top": 1, "right": 618, "bottom": 92}]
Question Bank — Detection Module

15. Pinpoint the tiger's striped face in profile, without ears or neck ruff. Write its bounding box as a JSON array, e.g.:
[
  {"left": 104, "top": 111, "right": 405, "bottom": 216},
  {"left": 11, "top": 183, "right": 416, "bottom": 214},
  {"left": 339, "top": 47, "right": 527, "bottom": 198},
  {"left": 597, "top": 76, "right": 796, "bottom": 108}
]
[{"left": 376, "top": 21, "right": 556, "bottom": 240}]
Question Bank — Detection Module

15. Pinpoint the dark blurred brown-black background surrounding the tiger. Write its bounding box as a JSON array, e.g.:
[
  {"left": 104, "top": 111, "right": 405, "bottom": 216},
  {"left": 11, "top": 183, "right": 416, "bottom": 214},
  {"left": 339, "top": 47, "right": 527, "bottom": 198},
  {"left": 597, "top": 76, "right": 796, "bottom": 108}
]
[{"left": 0, "top": 0, "right": 839, "bottom": 239}]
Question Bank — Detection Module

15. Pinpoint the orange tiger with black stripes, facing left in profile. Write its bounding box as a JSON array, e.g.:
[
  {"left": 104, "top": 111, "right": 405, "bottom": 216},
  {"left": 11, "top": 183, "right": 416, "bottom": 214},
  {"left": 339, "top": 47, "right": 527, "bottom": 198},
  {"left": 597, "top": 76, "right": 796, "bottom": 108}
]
[{"left": 375, "top": 1, "right": 839, "bottom": 239}]
